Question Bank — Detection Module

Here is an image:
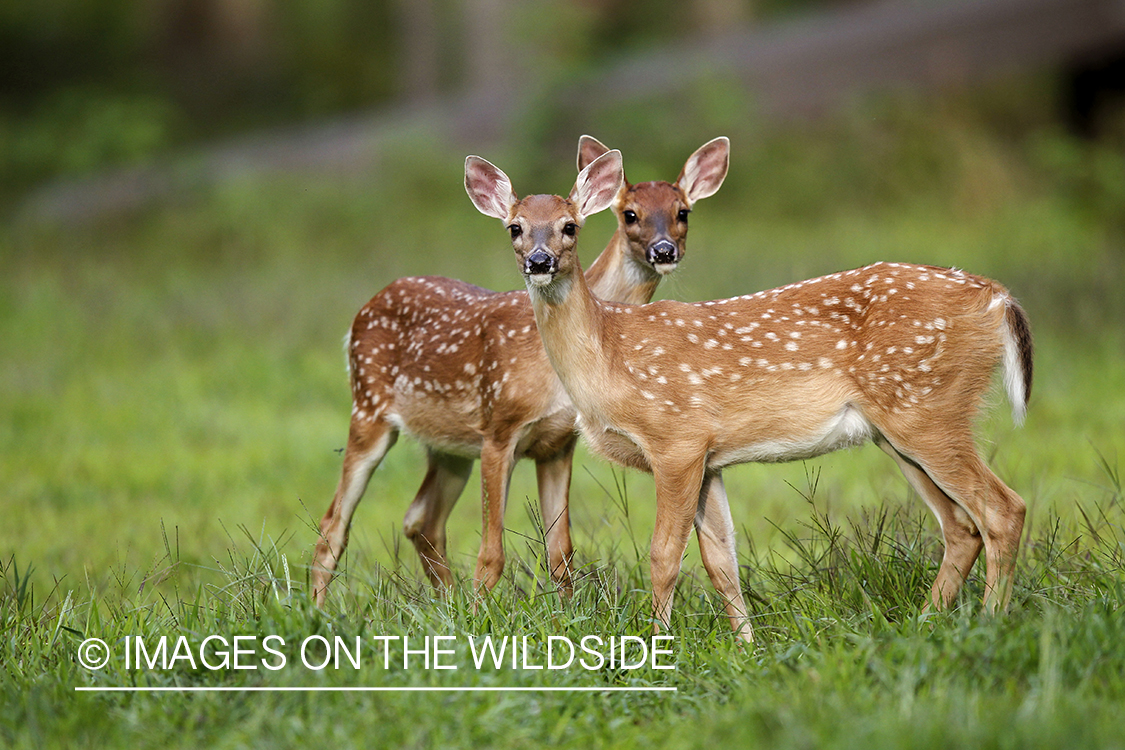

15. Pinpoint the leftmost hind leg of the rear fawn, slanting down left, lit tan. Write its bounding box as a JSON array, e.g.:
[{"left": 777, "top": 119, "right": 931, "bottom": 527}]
[{"left": 313, "top": 416, "right": 398, "bottom": 606}]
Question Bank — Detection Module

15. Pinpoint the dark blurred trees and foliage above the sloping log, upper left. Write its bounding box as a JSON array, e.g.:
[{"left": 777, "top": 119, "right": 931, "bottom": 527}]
[{"left": 0, "top": 0, "right": 801, "bottom": 193}]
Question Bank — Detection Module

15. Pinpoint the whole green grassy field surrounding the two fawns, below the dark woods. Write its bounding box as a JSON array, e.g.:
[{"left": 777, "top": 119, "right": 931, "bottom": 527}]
[{"left": 0, "top": 84, "right": 1125, "bottom": 748}]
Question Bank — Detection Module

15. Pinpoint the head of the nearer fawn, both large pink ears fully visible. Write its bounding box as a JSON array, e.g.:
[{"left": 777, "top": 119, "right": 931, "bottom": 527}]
[{"left": 465, "top": 150, "right": 624, "bottom": 290}]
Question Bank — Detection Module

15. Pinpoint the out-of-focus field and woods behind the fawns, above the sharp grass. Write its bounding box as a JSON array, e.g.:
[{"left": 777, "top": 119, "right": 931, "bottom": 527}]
[{"left": 0, "top": 0, "right": 1125, "bottom": 598}]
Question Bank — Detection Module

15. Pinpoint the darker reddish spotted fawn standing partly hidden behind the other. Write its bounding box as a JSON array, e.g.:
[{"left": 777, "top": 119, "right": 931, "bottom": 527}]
[{"left": 312, "top": 136, "right": 730, "bottom": 606}]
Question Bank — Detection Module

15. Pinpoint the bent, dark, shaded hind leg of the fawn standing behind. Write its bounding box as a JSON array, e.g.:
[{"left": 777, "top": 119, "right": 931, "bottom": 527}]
[{"left": 403, "top": 450, "right": 473, "bottom": 589}]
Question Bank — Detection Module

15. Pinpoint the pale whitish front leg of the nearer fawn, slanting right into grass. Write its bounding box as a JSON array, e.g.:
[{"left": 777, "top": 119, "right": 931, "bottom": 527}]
[{"left": 695, "top": 472, "right": 754, "bottom": 643}]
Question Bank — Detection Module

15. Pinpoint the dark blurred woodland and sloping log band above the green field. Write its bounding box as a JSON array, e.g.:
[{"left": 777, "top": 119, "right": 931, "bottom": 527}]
[{"left": 0, "top": 0, "right": 1125, "bottom": 216}]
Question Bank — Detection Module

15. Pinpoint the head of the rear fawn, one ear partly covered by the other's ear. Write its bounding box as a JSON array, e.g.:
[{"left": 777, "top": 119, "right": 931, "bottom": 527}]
[{"left": 578, "top": 135, "right": 730, "bottom": 275}]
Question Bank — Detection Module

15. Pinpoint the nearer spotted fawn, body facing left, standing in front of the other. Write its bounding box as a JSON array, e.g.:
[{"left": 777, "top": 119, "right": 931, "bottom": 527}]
[{"left": 465, "top": 152, "right": 1033, "bottom": 642}]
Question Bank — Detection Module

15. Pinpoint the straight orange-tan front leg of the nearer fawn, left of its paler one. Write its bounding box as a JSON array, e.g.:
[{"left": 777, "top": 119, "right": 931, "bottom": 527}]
[{"left": 649, "top": 451, "right": 705, "bottom": 632}]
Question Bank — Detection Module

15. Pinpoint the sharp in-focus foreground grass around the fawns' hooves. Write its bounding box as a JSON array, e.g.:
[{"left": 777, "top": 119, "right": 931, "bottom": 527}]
[{"left": 0, "top": 479, "right": 1125, "bottom": 747}]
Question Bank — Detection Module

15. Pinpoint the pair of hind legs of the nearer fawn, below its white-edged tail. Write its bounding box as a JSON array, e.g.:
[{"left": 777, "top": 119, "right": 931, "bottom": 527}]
[{"left": 884, "top": 428, "right": 1026, "bottom": 612}]
